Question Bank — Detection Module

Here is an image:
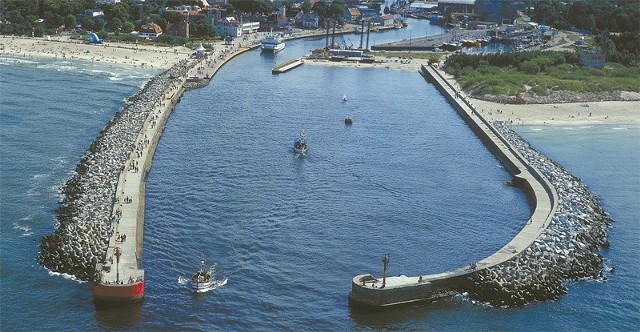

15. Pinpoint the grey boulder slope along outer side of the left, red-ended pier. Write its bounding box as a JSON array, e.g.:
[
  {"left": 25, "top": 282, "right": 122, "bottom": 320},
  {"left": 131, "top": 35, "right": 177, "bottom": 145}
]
[{"left": 38, "top": 60, "right": 195, "bottom": 281}]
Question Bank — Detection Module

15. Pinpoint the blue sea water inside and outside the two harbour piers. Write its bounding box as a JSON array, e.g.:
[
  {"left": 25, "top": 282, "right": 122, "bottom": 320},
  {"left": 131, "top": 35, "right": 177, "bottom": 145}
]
[{"left": 0, "top": 20, "right": 640, "bottom": 331}]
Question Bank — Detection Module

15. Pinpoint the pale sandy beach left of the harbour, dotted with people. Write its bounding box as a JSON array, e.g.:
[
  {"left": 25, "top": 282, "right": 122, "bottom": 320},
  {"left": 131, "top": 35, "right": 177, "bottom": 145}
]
[{"left": 0, "top": 35, "right": 193, "bottom": 69}]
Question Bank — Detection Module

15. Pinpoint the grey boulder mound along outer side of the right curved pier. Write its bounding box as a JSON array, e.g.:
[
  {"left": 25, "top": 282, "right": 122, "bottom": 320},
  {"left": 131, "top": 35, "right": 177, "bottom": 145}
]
[{"left": 465, "top": 122, "right": 611, "bottom": 306}]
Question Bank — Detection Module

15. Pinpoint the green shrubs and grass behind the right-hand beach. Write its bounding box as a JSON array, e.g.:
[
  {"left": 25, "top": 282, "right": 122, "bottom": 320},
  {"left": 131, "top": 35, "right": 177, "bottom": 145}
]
[{"left": 446, "top": 51, "right": 640, "bottom": 96}]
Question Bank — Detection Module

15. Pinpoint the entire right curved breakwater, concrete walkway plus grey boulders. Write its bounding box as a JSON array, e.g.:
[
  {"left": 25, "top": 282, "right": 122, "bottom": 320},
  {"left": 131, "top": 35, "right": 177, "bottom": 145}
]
[{"left": 349, "top": 66, "right": 610, "bottom": 309}]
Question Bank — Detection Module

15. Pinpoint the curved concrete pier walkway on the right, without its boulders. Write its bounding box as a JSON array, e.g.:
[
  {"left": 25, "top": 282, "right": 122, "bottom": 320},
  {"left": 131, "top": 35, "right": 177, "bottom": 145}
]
[{"left": 350, "top": 65, "right": 558, "bottom": 308}]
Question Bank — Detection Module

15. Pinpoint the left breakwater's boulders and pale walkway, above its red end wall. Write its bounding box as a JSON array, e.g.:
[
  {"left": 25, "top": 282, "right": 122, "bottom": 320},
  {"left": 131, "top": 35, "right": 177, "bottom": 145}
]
[{"left": 38, "top": 59, "right": 194, "bottom": 295}]
